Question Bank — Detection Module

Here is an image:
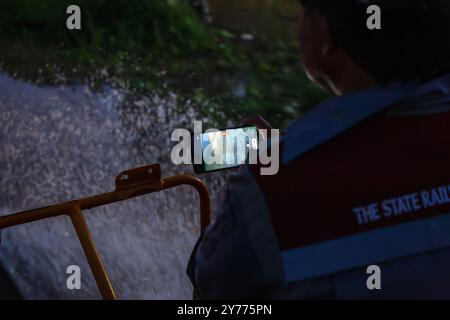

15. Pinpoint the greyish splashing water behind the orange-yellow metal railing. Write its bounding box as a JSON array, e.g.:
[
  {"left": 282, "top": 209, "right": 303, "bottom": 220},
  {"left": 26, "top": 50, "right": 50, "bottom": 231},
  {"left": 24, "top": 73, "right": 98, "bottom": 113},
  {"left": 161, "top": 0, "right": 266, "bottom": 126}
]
[{"left": 0, "top": 74, "right": 225, "bottom": 299}]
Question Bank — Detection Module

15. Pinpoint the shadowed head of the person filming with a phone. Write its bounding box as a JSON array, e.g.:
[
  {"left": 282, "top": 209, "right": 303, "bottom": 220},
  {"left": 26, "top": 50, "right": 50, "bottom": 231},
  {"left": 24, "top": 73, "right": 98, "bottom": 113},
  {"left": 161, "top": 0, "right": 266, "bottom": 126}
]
[{"left": 299, "top": 0, "right": 450, "bottom": 95}]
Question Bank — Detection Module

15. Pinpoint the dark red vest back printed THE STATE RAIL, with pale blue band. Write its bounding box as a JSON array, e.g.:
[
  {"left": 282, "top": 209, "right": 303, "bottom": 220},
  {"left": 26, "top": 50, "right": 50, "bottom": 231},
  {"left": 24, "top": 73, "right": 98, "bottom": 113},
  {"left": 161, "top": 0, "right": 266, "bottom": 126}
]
[{"left": 253, "top": 112, "right": 450, "bottom": 281}]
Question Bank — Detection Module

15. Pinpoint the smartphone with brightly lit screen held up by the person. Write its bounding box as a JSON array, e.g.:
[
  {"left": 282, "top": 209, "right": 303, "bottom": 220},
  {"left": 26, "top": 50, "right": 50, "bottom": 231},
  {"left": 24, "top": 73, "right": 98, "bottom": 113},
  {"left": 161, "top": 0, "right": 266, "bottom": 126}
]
[{"left": 191, "top": 126, "right": 258, "bottom": 174}]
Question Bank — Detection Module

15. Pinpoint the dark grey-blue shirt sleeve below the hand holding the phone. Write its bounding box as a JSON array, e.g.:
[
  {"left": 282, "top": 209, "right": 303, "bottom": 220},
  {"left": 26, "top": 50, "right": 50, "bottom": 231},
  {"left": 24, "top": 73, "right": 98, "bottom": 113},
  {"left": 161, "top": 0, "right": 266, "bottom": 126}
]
[{"left": 188, "top": 167, "right": 283, "bottom": 299}]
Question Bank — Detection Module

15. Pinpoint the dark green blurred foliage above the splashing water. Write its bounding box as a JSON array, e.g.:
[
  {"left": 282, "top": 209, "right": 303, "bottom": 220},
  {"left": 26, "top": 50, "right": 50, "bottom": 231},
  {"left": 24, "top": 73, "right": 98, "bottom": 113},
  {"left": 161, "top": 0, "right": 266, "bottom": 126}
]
[{"left": 0, "top": 0, "right": 324, "bottom": 126}]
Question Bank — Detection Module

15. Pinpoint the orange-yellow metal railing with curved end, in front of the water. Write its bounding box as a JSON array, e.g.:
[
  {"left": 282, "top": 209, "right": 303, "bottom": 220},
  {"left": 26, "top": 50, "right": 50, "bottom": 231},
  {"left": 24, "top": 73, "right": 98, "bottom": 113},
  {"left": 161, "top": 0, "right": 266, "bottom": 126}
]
[{"left": 0, "top": 164, "right": 211, "bottom": 300}]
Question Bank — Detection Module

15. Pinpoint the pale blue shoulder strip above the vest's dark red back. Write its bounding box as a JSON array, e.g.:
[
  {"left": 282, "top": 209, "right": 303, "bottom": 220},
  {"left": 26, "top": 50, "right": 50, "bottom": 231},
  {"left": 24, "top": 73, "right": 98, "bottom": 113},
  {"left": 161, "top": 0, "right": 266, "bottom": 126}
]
[{"left": 282, "top": 75, "right": 450, "bottom": 164}]
